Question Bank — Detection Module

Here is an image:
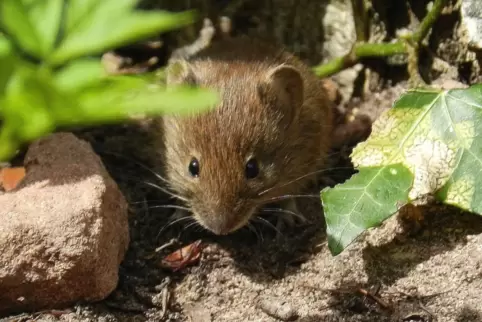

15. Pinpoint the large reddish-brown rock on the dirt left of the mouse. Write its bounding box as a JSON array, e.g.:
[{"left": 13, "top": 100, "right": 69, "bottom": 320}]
[{"left": 0, "top": 133, "right": 129, "bottom": 314}]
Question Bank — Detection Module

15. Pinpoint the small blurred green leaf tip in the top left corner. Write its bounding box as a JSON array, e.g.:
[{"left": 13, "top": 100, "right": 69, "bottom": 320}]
[{"left": 0, "top": 0, "right": 43, "bottom": 57}]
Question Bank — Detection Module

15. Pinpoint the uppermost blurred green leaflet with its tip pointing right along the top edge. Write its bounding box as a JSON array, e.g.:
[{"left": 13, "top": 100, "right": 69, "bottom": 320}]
[{"left": 50, "top": 0, "right": 195, "bottom": 65}]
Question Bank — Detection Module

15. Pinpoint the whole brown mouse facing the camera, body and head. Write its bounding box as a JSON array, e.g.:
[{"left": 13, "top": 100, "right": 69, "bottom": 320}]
[{"left": 162, "top": 37, "right": 333, "bottom": 235}]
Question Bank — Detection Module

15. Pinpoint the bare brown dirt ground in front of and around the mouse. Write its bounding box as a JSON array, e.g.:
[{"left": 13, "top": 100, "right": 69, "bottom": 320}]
[{"left": 0, "top": 77, "right": 482, "bottom": 322}]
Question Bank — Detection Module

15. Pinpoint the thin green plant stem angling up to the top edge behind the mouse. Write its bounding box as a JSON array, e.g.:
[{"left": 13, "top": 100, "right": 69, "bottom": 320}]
[{"left": 313, "top": 0, "right": 447, "bottom": 78}]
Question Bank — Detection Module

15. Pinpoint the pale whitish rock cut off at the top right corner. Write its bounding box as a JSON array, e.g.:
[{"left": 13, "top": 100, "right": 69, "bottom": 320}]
[{"left": 460, "top": 0, "right": 482, "bottom": 49}]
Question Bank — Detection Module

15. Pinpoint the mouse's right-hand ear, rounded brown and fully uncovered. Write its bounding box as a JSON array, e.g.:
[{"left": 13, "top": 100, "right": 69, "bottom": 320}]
[{"left": 258, "top": 64, "right": 304, "bottom": 126}]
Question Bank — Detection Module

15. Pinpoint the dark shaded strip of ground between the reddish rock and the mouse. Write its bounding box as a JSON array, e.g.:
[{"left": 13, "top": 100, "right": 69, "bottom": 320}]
[{"left": 69, "top": 122, "right": 177, "bottom": 321}]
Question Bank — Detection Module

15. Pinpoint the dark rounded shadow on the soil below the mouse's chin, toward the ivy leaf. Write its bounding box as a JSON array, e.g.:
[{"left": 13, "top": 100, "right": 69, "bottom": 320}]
[{"left": 200, "top": 195, "right": 325, "bottom": 283}]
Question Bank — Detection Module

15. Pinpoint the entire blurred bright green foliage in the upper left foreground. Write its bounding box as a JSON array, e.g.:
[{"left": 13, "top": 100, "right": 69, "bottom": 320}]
[{"left": 0, "top": 0, "right": 217, "bottom": 161}]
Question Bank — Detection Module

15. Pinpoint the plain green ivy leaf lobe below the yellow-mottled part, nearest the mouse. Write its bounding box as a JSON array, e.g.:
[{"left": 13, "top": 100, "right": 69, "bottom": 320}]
[{"left": 321, "top": 164, "right": 413, "bottom": 255}]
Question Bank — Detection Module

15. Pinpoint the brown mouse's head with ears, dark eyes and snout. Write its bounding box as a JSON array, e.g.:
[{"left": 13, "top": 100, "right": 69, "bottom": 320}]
[{"left": 163, "top": 61, "right": 303, "bottom": 234}]
